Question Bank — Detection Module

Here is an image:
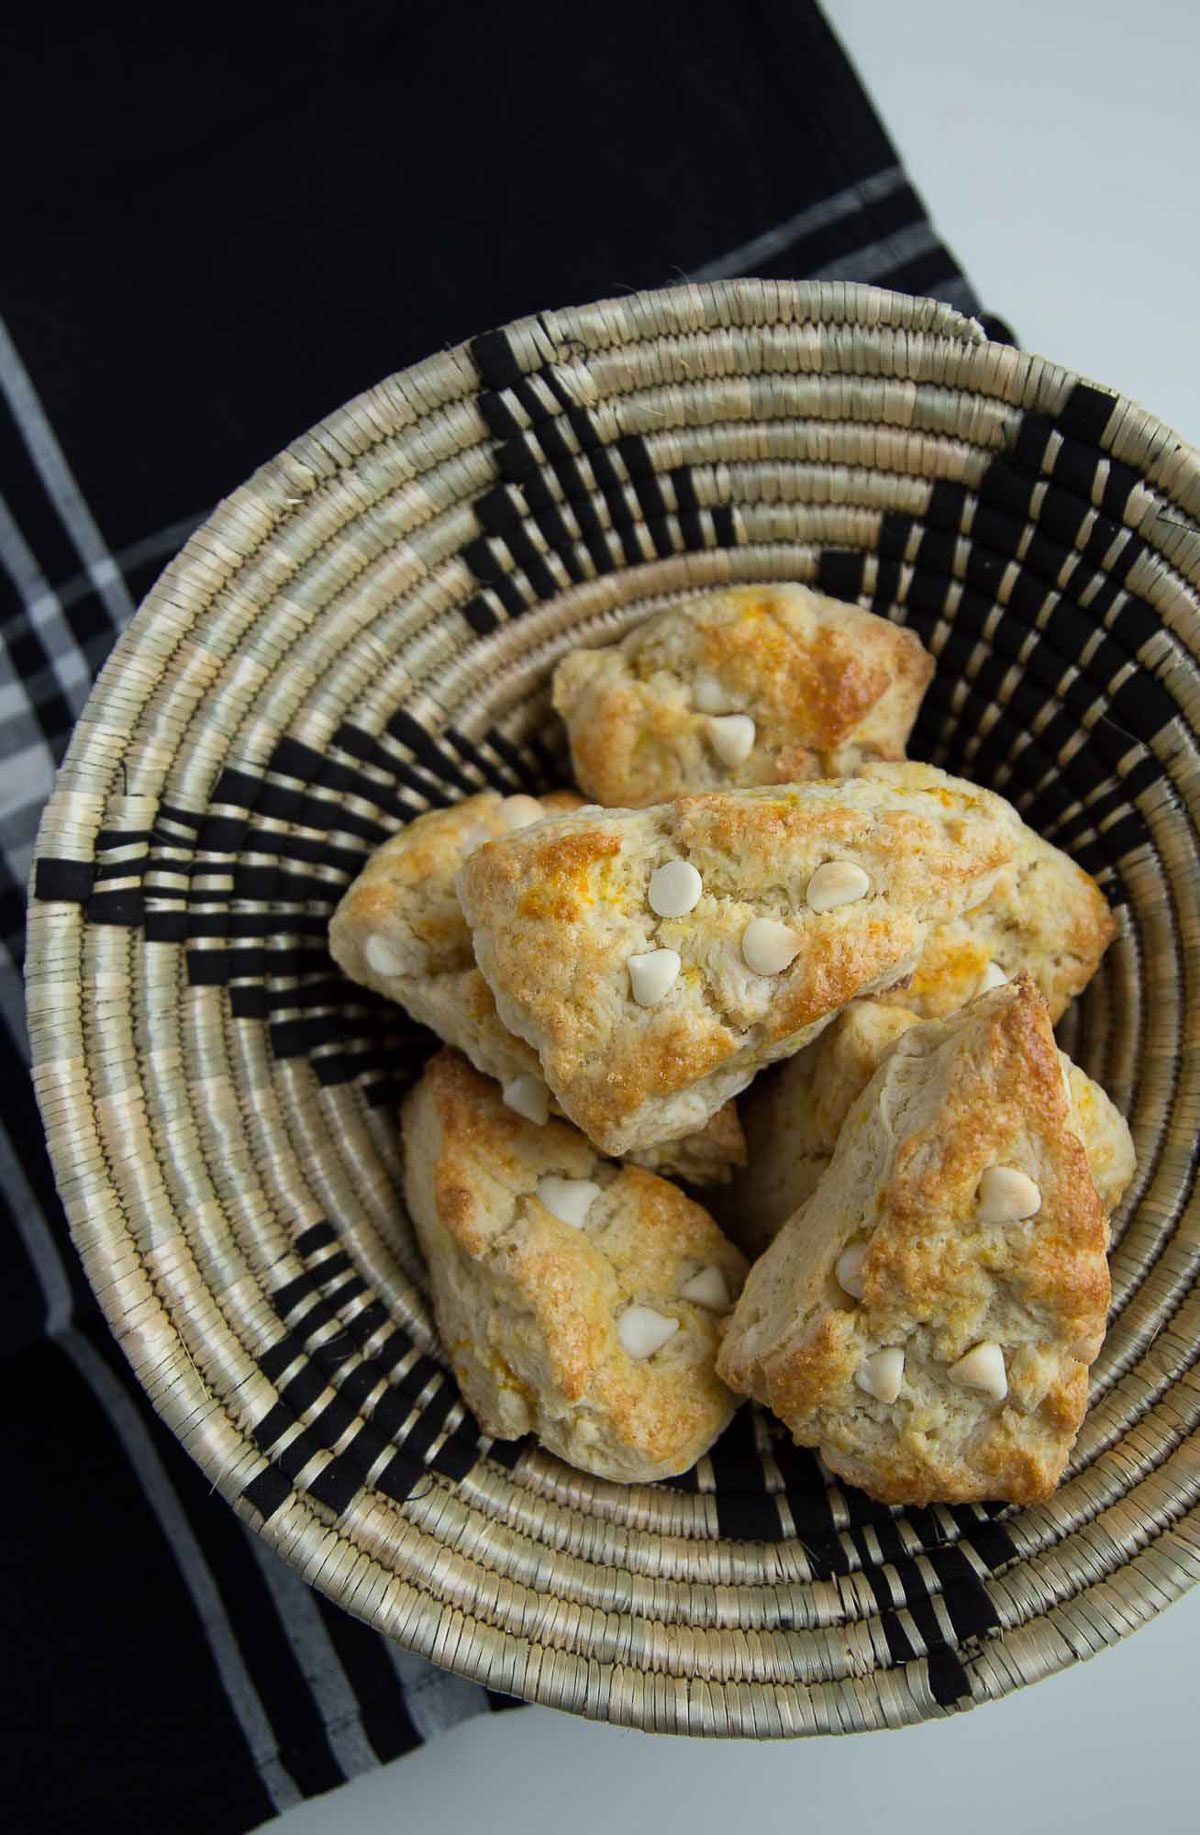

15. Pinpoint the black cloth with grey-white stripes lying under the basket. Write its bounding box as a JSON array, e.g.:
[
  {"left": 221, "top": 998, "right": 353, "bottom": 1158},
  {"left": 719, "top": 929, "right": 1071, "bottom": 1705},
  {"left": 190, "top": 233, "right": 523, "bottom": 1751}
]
[{"left": 0, "top": 0, "right": 1012, "bottom": 1835}]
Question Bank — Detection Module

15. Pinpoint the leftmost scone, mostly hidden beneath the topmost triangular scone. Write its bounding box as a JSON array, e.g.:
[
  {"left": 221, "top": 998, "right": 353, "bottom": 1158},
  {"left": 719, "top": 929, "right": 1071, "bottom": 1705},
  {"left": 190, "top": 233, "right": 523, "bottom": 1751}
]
[{"left": 328, "top": 791, "right": 745, "bottom": 1184}]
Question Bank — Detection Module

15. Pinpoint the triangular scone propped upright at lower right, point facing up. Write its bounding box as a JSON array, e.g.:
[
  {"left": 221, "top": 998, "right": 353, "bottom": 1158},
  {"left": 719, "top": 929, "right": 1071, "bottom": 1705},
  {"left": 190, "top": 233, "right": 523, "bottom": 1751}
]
[{"left": 717, "top": 976, "right": 1110, "bottom": 1505}]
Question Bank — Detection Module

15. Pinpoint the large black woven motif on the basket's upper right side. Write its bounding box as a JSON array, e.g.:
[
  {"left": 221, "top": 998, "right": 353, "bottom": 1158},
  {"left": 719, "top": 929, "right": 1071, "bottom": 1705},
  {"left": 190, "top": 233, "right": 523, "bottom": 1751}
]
[{"left": 818, "top": 384, "right": 1174, "bottom": 888}]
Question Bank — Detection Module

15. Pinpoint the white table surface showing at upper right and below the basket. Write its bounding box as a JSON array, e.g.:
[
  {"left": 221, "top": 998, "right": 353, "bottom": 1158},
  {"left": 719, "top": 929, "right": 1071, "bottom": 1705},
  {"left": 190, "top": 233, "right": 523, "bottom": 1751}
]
[{"left": 272, "top": 0, "right": 1200, "bottom": 1835}]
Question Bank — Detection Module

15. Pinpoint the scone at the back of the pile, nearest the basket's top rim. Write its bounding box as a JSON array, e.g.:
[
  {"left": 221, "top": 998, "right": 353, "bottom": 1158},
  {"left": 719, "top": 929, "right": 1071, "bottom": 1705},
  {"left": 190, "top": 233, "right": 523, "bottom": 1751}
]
[{"left": 554, "top": 585, "right": 934, "bottom": 809}]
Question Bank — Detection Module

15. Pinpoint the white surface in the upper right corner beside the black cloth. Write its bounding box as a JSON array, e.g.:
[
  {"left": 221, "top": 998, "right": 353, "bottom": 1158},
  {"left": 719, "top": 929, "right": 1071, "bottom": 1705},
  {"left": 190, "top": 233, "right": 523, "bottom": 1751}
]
[{"left": 836, "top": 0, "right": 1200, "bottom": 444}]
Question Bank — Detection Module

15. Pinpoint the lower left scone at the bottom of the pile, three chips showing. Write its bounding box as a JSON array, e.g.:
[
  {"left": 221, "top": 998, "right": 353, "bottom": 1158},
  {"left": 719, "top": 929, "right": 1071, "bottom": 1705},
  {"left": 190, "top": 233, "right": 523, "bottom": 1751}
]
[{"left": 404, "top": 1051, "right": 745, "bottom": 1485}]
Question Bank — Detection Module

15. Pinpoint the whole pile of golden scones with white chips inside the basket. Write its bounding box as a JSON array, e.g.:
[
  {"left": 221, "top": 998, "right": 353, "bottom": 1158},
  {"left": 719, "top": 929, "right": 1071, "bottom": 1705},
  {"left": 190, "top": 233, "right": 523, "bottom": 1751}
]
[{"left": 330, "top": 585, "right": 1134, "bottom": 1503}]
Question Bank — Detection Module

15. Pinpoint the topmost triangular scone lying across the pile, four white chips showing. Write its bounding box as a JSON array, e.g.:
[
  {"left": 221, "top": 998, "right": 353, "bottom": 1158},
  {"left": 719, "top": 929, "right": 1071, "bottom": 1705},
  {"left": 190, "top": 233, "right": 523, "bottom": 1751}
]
[{"left": 457, "top": 774, "right": 1013, "bottom": 1154}]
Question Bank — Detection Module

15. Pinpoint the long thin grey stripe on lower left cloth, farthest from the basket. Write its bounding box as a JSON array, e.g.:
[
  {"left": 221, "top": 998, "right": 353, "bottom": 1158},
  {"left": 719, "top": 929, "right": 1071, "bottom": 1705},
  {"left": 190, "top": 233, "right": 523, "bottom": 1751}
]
[{"left": 0, "top": 1123, "right": 301, "bottom": 1809}]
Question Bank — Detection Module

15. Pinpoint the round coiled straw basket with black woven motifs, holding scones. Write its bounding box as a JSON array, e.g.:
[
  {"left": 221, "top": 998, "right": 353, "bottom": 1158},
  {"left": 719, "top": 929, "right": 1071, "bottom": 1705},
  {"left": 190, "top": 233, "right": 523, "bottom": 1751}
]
[{"left": 29, "top": 281, "right": 1200, "bottom": 1736}]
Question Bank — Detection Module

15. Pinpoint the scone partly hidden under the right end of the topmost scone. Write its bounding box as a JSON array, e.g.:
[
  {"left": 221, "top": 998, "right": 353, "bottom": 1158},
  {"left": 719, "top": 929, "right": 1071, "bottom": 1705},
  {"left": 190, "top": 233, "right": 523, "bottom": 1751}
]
[{"left": 862, "top": 763, "right": 1117, "bottom": 1024}]
